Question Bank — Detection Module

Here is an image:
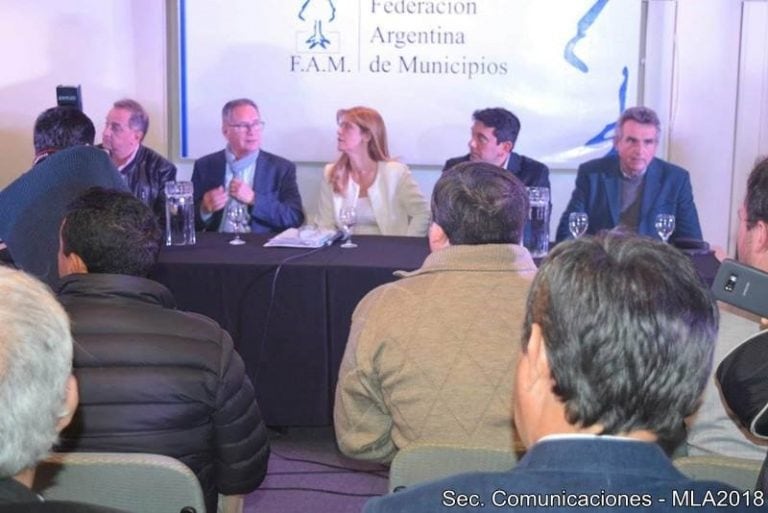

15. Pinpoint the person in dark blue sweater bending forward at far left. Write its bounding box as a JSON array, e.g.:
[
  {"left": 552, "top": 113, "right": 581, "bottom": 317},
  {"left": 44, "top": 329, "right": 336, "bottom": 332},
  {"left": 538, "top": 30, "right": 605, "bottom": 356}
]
[{"left": 0, "top": 107, "right": 127, "bottom": 289}]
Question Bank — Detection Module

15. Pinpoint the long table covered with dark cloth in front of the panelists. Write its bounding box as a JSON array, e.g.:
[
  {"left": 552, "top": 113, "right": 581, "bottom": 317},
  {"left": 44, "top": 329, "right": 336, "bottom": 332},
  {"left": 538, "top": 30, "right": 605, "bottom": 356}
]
[{"left": 148, "top": 233, "right": 719, "bottom": 426}]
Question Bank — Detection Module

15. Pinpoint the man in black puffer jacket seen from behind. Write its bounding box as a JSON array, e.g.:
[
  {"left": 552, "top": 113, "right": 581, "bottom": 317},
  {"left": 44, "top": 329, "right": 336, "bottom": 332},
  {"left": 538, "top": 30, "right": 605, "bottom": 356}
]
[{"left": 59, "top": 188, "right": 269, "bottom": 511}]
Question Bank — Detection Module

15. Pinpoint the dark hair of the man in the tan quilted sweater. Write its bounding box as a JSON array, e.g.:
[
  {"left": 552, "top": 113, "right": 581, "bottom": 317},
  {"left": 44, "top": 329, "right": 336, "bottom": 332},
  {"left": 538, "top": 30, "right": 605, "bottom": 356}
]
[{"left": 432, "top": 162, "right": 528, "bottom": 244}]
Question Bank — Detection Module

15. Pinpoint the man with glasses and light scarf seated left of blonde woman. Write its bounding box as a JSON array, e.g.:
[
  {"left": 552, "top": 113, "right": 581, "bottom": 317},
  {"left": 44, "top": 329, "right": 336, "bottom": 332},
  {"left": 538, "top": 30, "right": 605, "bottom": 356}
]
[{"left": 192, "top": 98, "right": 304, "bottom": 233}]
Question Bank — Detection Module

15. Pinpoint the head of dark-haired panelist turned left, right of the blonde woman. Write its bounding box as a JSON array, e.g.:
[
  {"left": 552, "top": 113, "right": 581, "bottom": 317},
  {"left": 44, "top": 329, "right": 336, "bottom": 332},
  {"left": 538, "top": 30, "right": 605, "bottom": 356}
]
[{"left": 469, "top": 107, "right": 520, "bottom": 166}]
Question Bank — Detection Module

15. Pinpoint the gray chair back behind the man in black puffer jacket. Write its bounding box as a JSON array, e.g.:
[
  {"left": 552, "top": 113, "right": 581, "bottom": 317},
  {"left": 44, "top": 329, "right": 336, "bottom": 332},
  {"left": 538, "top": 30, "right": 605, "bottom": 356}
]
[{"left": 33, "top": 452, "right": 205, "bottom": 513}]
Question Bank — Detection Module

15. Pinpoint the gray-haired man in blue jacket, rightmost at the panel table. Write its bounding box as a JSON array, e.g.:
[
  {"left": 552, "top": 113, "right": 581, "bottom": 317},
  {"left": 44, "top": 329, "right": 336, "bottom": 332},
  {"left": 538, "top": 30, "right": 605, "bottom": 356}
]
[{"left": 557, "top": 107, "right": 702, "bottom": 242}]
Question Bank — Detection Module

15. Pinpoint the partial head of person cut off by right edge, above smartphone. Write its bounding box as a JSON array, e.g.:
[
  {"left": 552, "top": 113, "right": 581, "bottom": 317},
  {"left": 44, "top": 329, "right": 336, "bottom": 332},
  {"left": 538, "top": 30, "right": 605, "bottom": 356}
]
[{"left": 738, "top": 158, "right": 768, "bottom": 269}]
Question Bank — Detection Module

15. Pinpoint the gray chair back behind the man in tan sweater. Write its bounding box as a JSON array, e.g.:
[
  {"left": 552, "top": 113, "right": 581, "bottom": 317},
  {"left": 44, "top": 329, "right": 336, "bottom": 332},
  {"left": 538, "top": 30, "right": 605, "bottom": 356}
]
[{"left": 389, "top": 445, "right": 517, "bottom": 492}]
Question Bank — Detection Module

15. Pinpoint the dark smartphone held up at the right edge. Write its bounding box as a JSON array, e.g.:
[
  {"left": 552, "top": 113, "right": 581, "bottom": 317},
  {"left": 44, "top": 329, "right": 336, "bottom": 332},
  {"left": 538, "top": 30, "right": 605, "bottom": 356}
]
[{"left": 712, "top": 259, "right": 768, "bottom": 318}]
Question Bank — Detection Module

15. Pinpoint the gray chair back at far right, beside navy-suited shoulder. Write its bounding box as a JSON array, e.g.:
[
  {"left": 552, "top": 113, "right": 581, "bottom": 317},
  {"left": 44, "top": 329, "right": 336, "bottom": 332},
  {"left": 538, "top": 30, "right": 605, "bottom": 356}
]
[{"left": 673, "top": 456, "right": 763, "bottom": 490}]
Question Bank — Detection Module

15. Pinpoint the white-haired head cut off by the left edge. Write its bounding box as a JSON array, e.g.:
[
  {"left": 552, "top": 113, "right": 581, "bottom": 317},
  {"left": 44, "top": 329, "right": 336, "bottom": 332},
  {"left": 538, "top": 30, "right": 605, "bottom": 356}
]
[{"left": 0, "top": 267, "right": 77, "bottom": 486}]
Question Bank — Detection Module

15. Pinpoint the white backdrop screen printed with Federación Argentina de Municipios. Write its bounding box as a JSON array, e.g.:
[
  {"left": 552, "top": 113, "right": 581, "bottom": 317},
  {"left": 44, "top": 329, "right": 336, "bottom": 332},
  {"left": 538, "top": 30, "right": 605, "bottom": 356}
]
[{"left": 179, "top": 0, "right": 642, "bottom": 164}]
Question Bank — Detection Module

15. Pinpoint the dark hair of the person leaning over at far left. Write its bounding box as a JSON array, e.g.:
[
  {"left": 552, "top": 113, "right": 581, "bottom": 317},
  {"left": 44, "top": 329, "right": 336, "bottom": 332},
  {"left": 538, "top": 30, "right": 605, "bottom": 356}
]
[{"left": 33, "top": 107, "right": 96, "bottom": 153}]
